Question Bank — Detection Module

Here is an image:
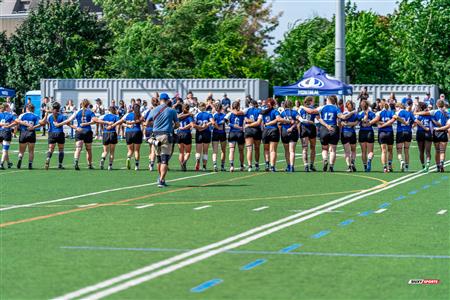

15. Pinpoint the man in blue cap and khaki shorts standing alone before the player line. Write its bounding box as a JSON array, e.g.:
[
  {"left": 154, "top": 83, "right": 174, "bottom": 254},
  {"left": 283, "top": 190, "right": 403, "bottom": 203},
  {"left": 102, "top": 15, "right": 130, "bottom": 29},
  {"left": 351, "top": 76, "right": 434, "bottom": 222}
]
[{"left": 147, "top": 93, "right": 179, "bottom": 188}]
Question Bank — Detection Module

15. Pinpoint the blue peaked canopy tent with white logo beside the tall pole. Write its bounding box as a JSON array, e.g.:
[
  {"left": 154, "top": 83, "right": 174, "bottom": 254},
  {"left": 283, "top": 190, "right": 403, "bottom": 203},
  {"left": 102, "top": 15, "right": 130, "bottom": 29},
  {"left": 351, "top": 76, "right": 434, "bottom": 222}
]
[{"left": 274, "top": 66, "right": 353, "bottom": 96}]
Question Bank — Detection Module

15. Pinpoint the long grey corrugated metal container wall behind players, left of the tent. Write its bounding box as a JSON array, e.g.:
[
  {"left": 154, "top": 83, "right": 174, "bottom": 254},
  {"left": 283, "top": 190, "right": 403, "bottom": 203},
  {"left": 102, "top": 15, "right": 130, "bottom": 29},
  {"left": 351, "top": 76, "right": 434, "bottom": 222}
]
[{"left": 41, "top": 79, "right": 269, "bottom": 106}]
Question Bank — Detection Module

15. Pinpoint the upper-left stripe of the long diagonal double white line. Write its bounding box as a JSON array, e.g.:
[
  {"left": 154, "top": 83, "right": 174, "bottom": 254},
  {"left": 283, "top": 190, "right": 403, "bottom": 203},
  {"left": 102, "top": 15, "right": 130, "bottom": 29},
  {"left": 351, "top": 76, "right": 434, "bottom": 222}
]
[{"left": 55, "top": 163, "right": 446, "bottom": 300}]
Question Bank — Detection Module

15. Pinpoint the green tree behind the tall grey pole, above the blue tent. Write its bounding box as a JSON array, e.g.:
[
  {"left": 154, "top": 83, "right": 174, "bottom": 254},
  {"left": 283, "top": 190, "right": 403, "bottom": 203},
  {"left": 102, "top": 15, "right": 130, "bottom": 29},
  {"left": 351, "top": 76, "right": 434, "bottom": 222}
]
[{"left": 273, "top": 2, "right": 393, "bottom": 84}]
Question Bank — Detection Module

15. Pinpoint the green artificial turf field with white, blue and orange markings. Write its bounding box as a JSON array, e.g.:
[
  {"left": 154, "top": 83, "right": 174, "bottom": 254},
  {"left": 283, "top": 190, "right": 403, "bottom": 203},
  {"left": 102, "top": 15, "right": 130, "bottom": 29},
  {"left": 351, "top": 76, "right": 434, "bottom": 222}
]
[{"left": 0, "top": 140, "right": 450, "bottom": 299}]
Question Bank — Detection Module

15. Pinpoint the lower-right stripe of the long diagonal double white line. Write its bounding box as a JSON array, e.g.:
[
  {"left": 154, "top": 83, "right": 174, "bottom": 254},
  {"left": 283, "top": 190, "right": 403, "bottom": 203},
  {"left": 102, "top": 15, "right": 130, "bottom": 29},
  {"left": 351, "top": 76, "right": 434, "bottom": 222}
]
[{"left": 74, "top": 163, "right": 446, "bottom": 300}]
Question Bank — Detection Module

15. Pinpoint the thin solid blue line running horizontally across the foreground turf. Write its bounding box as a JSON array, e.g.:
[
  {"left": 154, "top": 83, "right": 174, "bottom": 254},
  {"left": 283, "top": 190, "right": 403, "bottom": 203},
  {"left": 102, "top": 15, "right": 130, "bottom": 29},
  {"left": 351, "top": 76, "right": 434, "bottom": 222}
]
[{"left": 60, "top": 246, "right": 450, "bottom": 259}]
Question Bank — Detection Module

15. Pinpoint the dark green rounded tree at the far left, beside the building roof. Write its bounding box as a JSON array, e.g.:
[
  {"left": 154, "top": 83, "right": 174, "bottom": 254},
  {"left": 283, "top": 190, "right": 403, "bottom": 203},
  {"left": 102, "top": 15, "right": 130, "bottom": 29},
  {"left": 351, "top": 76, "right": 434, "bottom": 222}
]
[{"left": 7, "top": 1, "right": 111, "bottom": 92}]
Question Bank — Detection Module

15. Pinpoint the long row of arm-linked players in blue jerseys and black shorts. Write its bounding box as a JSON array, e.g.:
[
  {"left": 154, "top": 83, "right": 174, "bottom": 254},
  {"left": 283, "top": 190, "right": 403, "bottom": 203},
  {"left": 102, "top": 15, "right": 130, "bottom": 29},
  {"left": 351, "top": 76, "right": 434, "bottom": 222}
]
[{"left": 0, "top": 93, "right": 450, "bottom": 172}]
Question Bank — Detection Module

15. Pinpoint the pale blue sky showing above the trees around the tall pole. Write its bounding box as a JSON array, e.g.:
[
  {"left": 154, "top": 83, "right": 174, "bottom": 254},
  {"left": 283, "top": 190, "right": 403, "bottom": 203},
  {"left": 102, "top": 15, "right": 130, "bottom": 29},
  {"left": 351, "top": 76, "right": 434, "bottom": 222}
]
[{"left": 267, "top": 0, "right": 397, "bottom": 54}]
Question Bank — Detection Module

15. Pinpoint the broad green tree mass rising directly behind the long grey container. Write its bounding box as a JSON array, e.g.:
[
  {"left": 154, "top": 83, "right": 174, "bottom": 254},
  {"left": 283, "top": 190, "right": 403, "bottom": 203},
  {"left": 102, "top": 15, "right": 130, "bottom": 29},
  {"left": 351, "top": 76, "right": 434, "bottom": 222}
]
[{"left": 98, "top": 0, "right": 277, "bottom": 78}]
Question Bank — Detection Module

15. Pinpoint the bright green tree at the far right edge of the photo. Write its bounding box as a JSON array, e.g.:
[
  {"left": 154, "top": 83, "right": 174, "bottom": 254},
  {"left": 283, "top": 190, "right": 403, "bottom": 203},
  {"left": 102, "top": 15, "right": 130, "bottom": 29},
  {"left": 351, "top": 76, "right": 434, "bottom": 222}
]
[{"left": 391, "top": 0, "right": 450, "bottom": 93}]
